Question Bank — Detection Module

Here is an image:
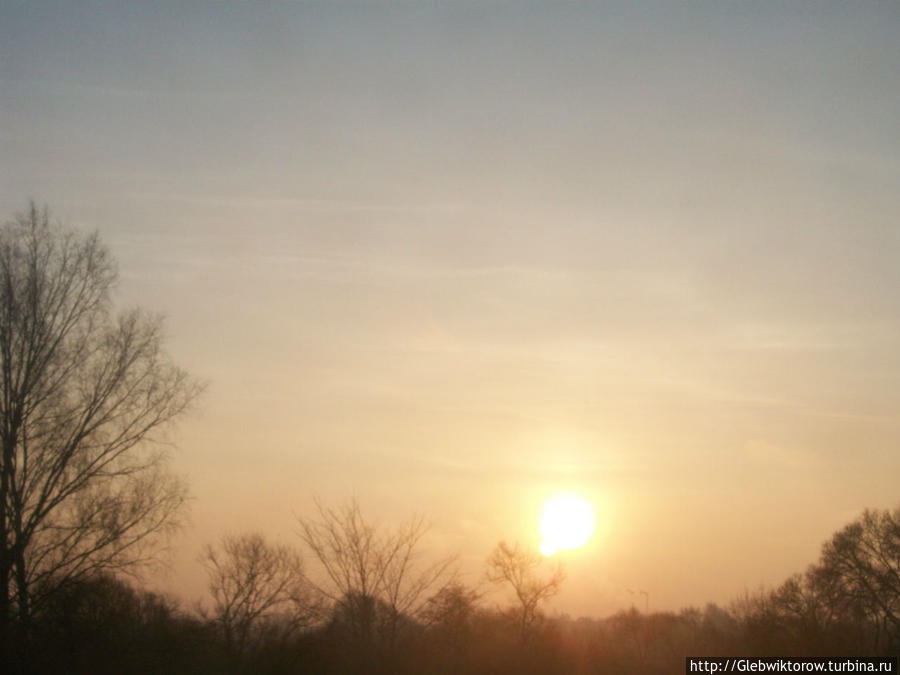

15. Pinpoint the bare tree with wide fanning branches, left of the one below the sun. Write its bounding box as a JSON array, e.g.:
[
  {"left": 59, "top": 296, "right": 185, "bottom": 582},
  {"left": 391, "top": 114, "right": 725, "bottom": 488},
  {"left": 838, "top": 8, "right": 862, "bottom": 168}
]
[{"left": 299, "top": 500, "right": 455, "bottom": 652}]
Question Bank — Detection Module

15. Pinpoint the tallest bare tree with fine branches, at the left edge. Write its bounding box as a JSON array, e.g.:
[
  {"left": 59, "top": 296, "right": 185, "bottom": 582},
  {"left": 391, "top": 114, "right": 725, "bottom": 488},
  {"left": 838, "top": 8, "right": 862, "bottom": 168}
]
[{"left": 0, "top": 205, "right": 200, "bottom": 657}]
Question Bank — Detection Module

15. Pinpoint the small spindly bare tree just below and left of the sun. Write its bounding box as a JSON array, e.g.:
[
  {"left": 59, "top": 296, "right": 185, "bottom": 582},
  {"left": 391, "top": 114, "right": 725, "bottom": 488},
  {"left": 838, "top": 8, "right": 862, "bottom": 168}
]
[{"left": 487, "top": 541, "right": 566, "bottom": 640}]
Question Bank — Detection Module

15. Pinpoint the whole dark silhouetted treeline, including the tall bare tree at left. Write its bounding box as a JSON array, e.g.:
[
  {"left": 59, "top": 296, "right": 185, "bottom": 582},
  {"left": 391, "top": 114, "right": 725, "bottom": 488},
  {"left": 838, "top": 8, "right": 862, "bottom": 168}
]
[{"left": 0, "top": 210, "right": 900, "bottom": 674}]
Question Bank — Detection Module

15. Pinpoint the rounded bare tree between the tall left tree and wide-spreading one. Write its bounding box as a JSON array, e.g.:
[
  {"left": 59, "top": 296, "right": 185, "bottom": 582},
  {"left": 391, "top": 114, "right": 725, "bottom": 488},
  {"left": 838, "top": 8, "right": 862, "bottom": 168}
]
[{"left": 201, "top": 533, "right": 312, "bottom": 662}]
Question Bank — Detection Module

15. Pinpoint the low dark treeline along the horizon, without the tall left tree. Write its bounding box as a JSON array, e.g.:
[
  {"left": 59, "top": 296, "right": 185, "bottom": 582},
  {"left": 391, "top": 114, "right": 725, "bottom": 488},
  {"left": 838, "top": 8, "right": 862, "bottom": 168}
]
[{"left": 17, "top": 503, "right": 900, "bottom": 675}]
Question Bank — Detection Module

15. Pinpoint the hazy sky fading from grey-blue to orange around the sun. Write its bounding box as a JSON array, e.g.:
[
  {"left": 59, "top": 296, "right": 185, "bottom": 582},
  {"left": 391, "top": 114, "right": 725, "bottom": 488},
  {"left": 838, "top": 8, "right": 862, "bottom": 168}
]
[{"left": 0, "top": 0, "right": 900, "bottom": 616}]
